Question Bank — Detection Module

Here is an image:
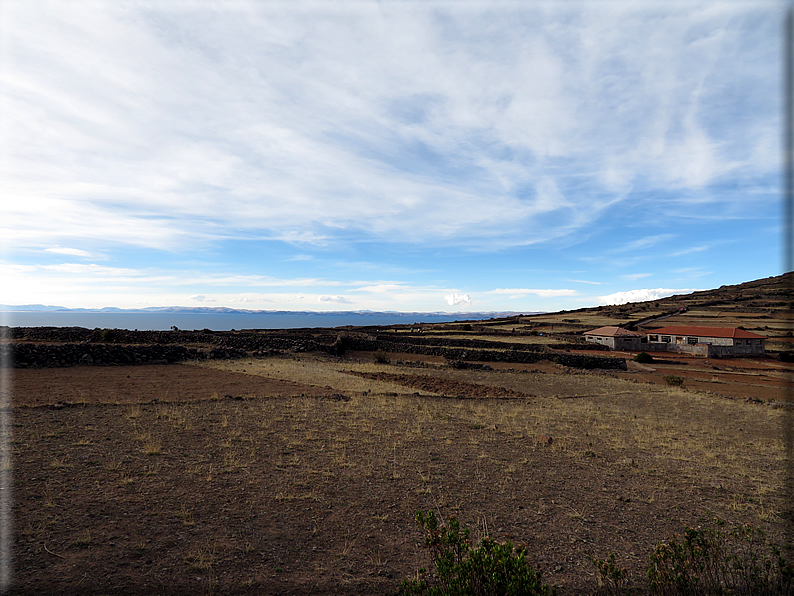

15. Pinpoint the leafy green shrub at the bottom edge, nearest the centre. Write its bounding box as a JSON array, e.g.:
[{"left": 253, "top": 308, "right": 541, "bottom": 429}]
[{"left": 401, "top": 511, "right": 556, "bottom": 596}]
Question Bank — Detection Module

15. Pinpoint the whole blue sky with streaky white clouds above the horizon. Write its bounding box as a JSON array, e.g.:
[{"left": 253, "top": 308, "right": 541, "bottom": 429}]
[{"left": 0, "top": 0, "right": 785, "bottom": 312}]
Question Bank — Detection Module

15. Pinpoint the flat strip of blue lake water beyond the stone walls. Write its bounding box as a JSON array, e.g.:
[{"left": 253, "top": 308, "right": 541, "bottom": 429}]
[{"left": 0, "top": 311, "right": 487, "bottom": 331}]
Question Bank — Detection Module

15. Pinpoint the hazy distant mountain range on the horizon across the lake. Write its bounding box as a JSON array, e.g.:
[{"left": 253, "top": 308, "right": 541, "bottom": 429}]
[{"left": 0, "top": 304, "right": 541, "bottom": 320}]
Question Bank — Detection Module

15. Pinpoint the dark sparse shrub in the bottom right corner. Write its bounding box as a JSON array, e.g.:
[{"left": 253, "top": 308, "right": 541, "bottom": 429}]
[{"left": 648, "top": 519, "right": 794, "bottom": 596}]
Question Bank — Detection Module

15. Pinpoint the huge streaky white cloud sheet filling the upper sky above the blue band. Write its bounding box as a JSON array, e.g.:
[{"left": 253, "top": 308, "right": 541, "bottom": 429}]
[{"left": 0, "top": 1, "right": 778, "bottom": 256}]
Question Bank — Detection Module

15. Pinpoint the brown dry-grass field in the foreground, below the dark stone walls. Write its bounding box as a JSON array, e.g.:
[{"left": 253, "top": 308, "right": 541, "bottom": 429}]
[{"left": 12, "top": 353, "right": 791, "bottom": 594}]
